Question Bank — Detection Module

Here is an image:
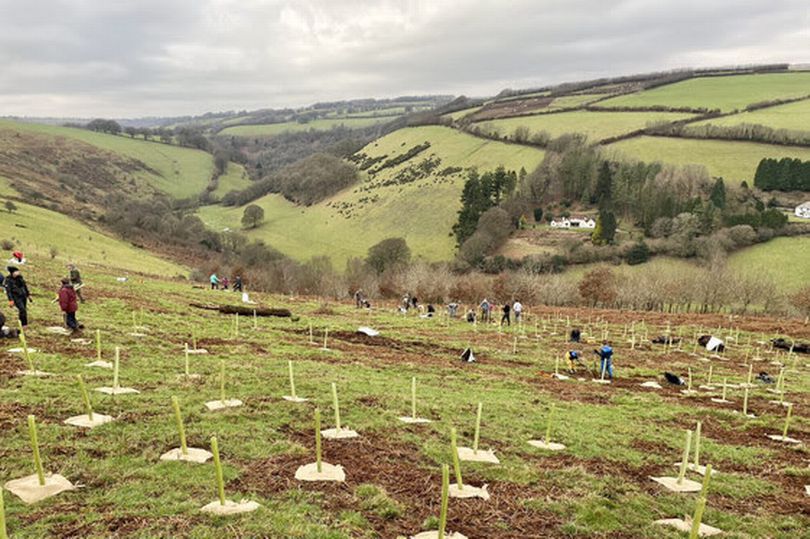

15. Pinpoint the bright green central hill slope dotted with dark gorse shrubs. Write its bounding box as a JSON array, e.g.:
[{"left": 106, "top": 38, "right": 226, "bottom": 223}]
[{"left": 200, "top": 126, "right": 543, "bottom": 268}]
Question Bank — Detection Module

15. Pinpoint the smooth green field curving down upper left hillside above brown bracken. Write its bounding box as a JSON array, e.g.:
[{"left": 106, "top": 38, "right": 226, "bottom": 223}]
[{"left": 0, "top": 119, "right": 214, "bottom": 198}]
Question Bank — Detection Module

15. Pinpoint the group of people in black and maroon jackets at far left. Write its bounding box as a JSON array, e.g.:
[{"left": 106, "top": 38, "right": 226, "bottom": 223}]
[{"left": 0, "top": 262, "right": 84, "bottom": 337}]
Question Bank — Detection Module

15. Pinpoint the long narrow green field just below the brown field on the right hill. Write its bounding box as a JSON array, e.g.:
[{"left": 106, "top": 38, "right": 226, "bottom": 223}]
[{"left": 476, "top": 110, "right": 691, "bottom": 141}]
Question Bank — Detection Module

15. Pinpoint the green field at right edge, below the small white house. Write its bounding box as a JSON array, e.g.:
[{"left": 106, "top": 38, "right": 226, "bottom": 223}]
[{"left": 729, "top": 236, "right": 810, "bottom": 290}]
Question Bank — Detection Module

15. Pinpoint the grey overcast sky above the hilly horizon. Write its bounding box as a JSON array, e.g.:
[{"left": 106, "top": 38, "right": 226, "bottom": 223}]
[{"left": 0, "top": 0, "right": 810, "bottom": 117}]
